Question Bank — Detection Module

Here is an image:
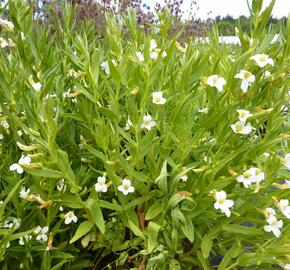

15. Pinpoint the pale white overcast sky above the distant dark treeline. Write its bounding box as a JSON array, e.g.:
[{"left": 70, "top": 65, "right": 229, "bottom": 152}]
[{"left": 143, "top": 0, "right": 290, "bottom": 19}]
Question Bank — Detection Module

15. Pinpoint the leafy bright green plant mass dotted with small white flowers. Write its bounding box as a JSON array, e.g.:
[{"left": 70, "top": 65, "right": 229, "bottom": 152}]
[{"left": 0, "top": 1, "right": 290, "bottom": 270}]
